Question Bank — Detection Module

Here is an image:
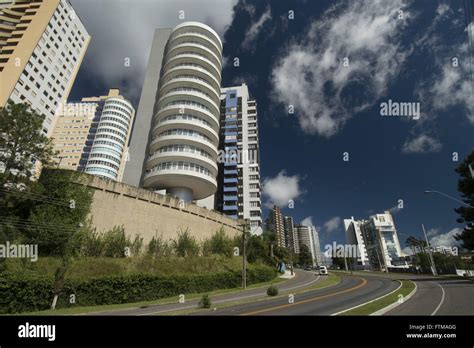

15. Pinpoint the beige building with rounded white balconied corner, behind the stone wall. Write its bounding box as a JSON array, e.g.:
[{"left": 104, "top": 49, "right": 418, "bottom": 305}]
[{"left": 52, "top": 89, "right": 135, "bottom": 181}]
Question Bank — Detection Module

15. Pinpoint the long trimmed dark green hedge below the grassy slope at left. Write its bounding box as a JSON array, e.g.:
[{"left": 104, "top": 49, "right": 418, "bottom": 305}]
[{"left": 0, "top": 265, "right": 276, "bottom": 314}]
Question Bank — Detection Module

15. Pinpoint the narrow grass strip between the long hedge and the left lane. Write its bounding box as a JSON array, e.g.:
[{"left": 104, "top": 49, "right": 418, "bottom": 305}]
[{"left": 13, "top": 277, "right": 287, "bottom": 316}]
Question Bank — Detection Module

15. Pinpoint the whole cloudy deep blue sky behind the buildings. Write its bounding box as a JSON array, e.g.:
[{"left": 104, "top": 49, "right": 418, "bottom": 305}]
[{"left": 70, "top": 0, "right": 474, "bottom": 250}]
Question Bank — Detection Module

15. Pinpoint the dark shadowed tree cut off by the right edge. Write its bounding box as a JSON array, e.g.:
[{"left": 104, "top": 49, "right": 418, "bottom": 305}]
[{"left": 454, "top": 150, "right": 474, "bottom": 250}]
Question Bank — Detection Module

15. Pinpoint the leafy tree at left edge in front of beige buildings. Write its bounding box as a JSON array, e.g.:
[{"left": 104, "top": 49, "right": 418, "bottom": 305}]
[{"left": 0, "top": 100, "right": 54, "bottom": 187}]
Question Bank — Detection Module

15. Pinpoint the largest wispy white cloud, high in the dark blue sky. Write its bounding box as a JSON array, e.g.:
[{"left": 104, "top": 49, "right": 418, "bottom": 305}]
[{"left": 272, "top": 0, "right": 410, "bottom": 137}]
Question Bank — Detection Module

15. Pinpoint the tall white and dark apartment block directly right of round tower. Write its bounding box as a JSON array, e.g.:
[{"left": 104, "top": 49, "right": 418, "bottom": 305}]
[{"left": 215, "top": 84, "right": 262, "bottom": 234}]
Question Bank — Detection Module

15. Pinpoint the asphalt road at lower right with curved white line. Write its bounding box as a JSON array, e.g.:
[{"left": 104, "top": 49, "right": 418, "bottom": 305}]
[{"left": 385, "top": 277, "right": 474, "bottom": 315}]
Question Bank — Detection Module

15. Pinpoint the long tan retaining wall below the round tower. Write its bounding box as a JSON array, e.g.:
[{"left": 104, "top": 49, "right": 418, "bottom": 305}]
[{"left": 72, "top": 174, "right": 242, "bottom": 244}]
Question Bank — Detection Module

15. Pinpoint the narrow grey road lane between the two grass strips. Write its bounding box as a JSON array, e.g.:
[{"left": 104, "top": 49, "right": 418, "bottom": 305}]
[{"left": 86, "top": 270, "right": 322, "bottom": 316}]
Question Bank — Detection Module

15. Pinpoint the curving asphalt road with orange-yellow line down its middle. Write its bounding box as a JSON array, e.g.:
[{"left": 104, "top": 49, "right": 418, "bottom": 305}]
[{"left": 198, "top": 275, "right": 399, "bottom": 315}]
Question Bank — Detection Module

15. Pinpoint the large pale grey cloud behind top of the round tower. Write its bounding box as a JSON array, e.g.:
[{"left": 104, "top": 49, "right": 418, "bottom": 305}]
[{"left": 72, "top": 0, "right": 237, "bottom": 99}]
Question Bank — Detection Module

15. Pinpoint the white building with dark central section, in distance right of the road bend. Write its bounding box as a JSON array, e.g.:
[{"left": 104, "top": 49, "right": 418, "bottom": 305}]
[{"left": 344, "top": 211, "right": 407, "bottom": 269}]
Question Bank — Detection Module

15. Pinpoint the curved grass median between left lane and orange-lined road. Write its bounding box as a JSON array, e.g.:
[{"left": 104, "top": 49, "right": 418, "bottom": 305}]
[{"left": 156, "top": 272, "right": 341, "bottom": 315}]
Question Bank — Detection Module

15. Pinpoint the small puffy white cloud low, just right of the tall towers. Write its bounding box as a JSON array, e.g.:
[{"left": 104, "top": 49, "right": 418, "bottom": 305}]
[{"left": 263, "top": 170, "right": 302, "bottom": 207}]
